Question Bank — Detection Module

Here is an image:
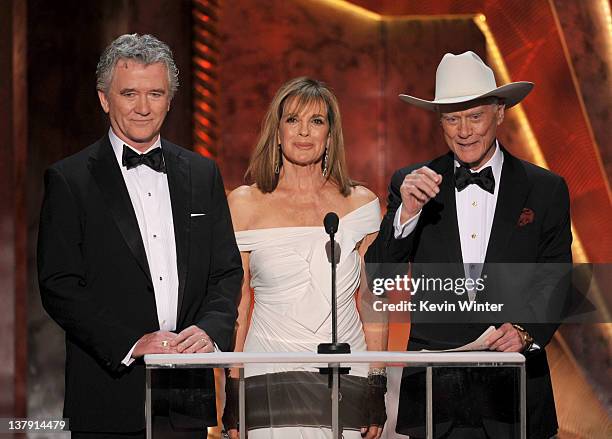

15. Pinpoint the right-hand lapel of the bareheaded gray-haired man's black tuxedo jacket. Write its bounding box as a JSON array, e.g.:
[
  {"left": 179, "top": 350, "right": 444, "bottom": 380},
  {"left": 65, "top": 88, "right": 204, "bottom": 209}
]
[{"left": 162, "top": 139, "right": 191, "bottom": 323}]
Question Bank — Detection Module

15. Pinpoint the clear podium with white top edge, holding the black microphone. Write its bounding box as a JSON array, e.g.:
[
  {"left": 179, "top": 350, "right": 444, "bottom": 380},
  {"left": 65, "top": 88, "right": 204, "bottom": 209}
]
[{"left": 144, "top": 351, "right": 527, "bottom": 439}]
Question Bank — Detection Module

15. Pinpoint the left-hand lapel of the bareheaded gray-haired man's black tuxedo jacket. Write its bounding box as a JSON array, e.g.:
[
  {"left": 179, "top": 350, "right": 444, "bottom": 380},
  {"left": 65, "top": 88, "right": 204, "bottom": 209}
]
[{"left": 89, "top": 136, "right": 152, "bottom": 284}]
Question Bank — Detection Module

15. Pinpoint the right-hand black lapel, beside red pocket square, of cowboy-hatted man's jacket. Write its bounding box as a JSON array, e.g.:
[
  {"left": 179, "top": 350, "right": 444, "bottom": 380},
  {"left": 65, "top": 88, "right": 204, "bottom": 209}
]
[{"left": 485, "top": 149, "right": 531, "bottom": 263}]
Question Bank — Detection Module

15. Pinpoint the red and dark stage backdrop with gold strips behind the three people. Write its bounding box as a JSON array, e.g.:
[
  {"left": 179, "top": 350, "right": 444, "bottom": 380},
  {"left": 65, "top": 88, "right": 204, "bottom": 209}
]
[{"left": 0, "top": 0, "right": 612, "bottom": 437}]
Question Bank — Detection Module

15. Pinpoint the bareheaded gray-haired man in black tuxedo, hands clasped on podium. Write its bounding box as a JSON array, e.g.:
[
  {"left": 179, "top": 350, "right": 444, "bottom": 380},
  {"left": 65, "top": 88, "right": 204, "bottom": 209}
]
[{"left": 38, "top": 34, "right": 243, "bottom": 438}]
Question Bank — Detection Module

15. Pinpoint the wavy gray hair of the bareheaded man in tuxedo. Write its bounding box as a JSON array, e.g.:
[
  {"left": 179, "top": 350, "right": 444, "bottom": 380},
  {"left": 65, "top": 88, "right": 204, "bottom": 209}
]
[{"left": 96, "top": 34, "right": 179, "bottom": 99}]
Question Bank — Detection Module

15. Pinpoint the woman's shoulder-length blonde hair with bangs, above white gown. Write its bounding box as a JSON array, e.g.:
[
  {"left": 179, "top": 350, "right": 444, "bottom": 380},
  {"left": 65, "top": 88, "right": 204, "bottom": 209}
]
[{"left": 244, "top": 76, "right": 355, "bottom": 197}]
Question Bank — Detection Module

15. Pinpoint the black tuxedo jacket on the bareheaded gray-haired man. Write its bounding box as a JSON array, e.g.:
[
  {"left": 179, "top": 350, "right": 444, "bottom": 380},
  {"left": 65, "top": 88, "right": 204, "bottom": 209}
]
[{"left": 37, "top": 135, "right": 243, "bottom": 432}]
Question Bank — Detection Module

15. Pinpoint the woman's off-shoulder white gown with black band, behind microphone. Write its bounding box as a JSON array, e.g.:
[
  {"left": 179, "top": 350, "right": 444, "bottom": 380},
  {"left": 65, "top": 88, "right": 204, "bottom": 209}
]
[{"left": 236, "top": 199, "right": 381, "bottom": 439}]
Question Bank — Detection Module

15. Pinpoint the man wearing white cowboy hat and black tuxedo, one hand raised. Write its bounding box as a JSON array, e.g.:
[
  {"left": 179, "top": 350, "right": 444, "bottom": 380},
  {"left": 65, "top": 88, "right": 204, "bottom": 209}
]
[{"left": 366, "top": 52, "right": 572, "bottom": 439}]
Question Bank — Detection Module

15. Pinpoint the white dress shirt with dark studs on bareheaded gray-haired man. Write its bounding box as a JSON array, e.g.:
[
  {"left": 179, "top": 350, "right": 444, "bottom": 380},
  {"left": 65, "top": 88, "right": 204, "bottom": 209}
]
[{"left": 108, "top": 128, "right": 178, "bottom": 365}]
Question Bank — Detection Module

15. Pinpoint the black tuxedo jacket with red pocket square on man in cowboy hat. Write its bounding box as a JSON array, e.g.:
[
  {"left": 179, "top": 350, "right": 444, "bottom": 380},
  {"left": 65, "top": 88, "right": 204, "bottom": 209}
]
[{"left": 365, "top": 148, "right": 572, "bottom": 438}]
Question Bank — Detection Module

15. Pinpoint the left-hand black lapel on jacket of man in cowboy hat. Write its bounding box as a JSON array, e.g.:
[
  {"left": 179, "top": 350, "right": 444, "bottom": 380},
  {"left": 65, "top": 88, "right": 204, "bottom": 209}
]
[{"left": 430, "top": 154, "right": 463, "bottom": 263}]
